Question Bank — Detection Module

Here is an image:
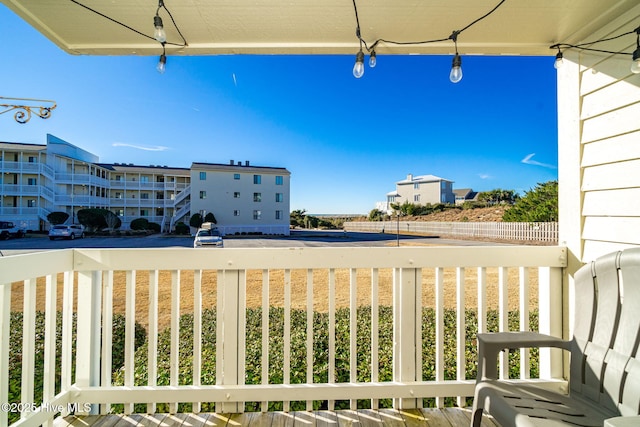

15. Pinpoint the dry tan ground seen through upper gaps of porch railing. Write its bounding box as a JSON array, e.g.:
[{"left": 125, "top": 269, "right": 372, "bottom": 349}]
[{"left": 11, "top": 268, "right": 538, "bottom": 330}]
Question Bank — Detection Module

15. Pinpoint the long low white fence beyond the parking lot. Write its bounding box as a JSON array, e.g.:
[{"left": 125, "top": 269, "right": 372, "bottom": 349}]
[{"left": 344, "top": 221, "right": 558, "bottom": 243}]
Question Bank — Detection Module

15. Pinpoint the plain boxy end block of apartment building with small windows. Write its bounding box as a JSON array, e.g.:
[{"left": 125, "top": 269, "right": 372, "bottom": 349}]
[{"left": 191, "top": 160, "right": 291, "bottom": 235}]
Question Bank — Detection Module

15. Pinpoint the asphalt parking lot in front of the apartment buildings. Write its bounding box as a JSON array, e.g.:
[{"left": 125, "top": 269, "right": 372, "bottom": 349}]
[{"left": 0, "top": 230, "right": 510, "bottom": 256}]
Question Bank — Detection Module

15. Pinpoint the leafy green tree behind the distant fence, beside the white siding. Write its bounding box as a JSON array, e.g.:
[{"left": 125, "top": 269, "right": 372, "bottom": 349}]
[{"left": 502, "top": 181, "right": 558, "bottom": 222}]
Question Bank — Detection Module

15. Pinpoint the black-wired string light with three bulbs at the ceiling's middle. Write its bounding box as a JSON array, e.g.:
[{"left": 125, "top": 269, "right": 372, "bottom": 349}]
[{"left": 353, "top": 0, "right": 507, "bottom": 83}]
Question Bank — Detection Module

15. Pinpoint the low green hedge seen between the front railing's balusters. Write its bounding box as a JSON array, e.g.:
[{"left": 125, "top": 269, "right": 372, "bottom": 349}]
[{"left": 113, "top": 306, "right": 538, "bottom": 412}]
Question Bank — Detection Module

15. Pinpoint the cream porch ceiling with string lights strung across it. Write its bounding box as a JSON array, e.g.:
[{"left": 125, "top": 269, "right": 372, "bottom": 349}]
[{"left": 0, "top": 0, "right": 637, "bottom": 55}]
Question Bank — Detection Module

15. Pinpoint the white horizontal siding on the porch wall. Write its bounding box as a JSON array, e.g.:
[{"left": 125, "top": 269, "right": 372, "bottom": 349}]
[{"left": 558, "top": 7, "right": 640, "bottom": 262}]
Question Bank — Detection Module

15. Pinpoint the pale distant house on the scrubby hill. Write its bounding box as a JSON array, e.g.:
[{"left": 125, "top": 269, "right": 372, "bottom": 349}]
[{"left": 376, "top": 174, "right": 456, "bottom": 213}]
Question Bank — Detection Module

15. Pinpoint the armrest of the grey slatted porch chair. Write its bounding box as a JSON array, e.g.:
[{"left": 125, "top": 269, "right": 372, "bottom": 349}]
[{"left": 478, "top": 332, "right": 571, "bottom": 381}]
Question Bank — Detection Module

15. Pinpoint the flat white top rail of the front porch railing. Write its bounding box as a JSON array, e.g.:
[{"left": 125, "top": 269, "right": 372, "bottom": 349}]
[{"left": 65, "top": 245, "right": 567, "bottom": 271}]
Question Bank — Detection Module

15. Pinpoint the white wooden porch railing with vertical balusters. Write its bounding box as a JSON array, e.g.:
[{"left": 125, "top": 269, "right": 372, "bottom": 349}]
[{"left": 0, "top": 246, "right": 567, "bottom": 426}]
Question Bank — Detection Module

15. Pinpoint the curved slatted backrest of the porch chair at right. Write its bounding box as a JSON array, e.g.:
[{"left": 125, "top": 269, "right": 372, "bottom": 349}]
[{"left": 570, "top": 248, "right": 640, "bottom": 415}]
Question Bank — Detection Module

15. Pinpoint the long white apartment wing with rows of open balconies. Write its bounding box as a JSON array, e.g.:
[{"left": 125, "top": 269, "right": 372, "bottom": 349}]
[{"left": 0, "top": 135, "right": 289, "bottom": 234}]
